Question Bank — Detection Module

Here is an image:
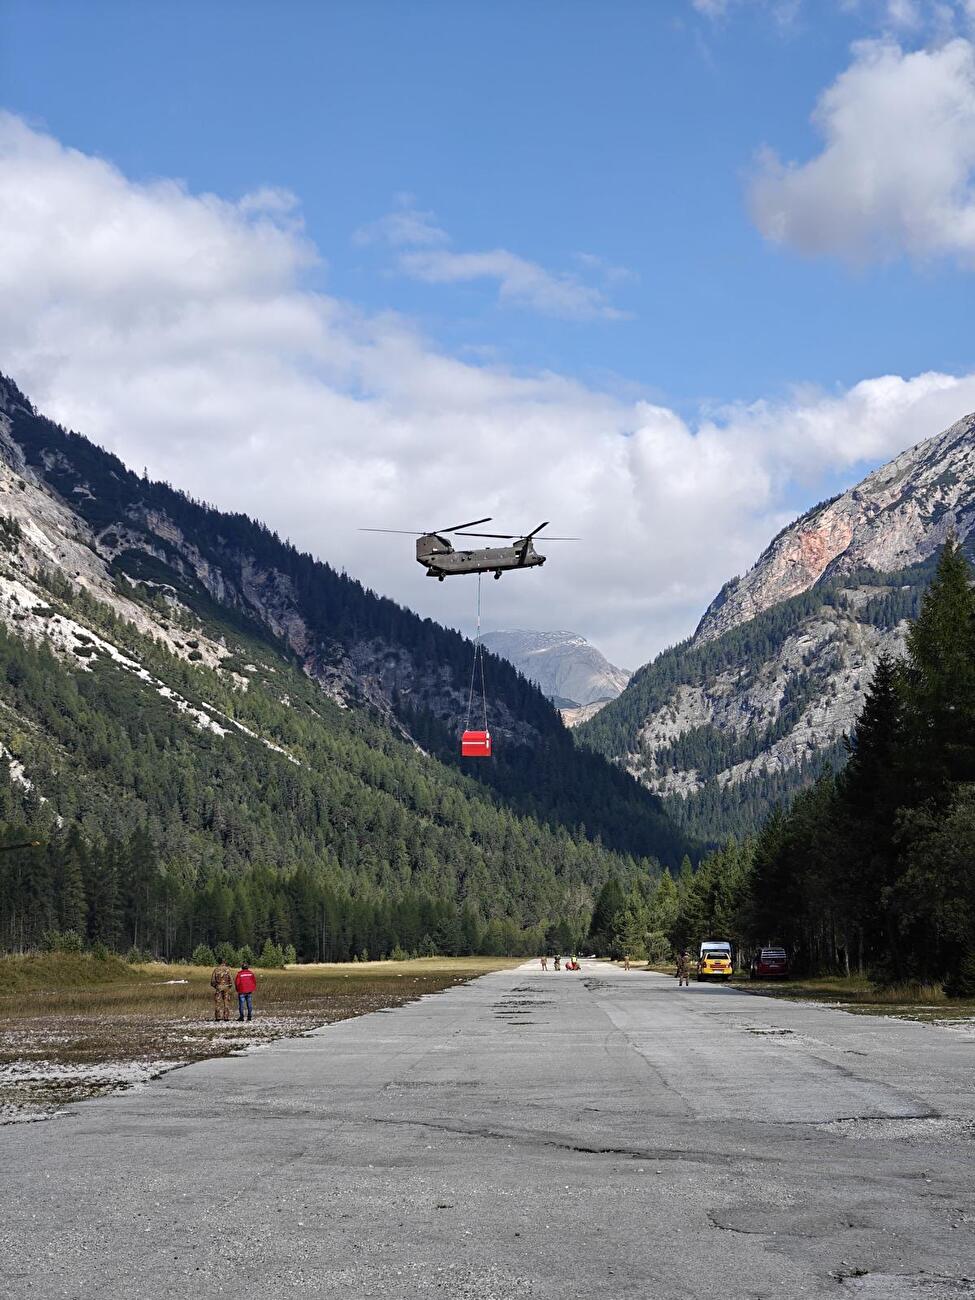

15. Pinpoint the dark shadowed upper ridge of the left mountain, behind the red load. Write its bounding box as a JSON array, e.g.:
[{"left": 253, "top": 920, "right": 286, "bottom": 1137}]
[{"left": 0, "top": 377, "right": 685, "bottom": 859}]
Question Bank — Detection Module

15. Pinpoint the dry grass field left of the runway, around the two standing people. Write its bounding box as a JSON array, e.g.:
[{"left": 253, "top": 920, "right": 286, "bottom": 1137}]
[{"left": 0, "top": 953, "right": 519, "bottom": 1122}]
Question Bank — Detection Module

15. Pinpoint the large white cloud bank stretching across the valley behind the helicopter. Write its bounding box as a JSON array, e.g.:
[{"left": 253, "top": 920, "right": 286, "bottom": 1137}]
[{"left": 0, "top": 117, "right": 975, "bottom": 667}]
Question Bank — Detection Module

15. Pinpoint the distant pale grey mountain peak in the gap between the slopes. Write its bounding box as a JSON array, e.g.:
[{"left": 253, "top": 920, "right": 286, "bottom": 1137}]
[{"left": 481, "top": 629, "right": 631, "bottom": 718}]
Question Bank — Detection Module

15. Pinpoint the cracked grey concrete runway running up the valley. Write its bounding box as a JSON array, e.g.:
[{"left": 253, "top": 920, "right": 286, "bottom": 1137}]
[{"left": 0, "top": 962, "right": 975, "bottom": 1300}]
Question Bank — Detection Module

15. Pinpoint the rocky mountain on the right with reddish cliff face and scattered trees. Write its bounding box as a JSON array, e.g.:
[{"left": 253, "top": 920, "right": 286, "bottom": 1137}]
[{"left": 576, "top": 416, "right": 975, "bottom": 840}]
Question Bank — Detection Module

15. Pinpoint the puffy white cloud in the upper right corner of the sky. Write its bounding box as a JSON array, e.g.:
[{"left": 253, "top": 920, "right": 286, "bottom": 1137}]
[{"left": 750, "top": 38, "right": 975, "bottom": 267}]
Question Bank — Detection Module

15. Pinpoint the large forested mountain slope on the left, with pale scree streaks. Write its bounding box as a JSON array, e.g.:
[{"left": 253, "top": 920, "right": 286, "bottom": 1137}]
[{"left": 0, "top": 377, "right": 688, "bottom": 957}]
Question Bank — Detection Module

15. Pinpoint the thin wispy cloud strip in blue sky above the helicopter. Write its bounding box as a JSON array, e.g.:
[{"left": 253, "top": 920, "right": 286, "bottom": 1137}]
[{"left": 354, "top": 195, "right": 627, "bottom": 320}]
